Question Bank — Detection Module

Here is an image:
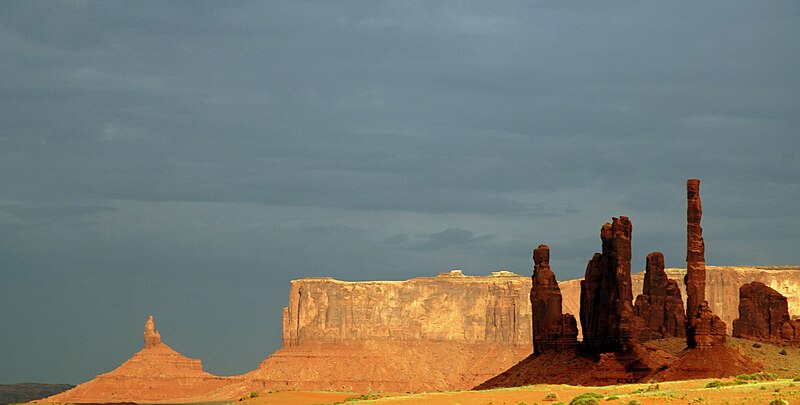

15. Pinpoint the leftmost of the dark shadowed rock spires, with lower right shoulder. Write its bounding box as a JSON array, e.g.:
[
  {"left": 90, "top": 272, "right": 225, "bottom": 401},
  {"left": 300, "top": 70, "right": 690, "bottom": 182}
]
[{"left": 531, "top": 245, "right": 578, "bottom": 354}]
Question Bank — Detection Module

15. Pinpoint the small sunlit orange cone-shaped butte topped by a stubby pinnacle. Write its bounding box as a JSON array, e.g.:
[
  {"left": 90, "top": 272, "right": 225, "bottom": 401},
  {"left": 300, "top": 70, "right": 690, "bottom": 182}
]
[{"left": 47, "top": 315, "right": 237, "bottom": 403}]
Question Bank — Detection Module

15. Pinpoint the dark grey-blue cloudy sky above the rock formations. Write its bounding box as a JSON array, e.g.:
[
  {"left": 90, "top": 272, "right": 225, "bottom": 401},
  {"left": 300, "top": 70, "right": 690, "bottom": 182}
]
[{"left": 0, "top": 0, "right": 800, "bottom": 384}]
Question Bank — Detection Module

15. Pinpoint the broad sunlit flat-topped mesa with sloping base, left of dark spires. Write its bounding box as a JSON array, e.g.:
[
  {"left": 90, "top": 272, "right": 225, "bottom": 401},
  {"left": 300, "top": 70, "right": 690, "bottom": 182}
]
[{"left": 253, "top": 271, "right": 533, "bottom": 392}]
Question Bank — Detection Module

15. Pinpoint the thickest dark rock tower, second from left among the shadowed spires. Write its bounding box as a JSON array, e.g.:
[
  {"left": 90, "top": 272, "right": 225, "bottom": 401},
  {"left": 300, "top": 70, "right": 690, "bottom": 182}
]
[{"left": 580, "top": 216, "right": 636, "bottom": 353}]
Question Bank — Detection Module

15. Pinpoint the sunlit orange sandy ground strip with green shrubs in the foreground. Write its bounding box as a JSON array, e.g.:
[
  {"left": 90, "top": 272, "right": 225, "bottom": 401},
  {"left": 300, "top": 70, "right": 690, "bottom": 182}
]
[{"left": 239, "top": 379, "right": 800, "bottom": 405}]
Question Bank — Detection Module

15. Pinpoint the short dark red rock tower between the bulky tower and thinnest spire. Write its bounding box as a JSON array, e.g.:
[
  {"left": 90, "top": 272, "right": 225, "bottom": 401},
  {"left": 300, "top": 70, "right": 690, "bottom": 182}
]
[{"left": 634, "top": 252, "right": 686, "bottom": 342}]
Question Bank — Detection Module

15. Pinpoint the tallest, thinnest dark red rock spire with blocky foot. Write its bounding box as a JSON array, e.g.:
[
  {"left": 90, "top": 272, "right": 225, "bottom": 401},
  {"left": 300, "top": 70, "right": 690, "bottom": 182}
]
[{"left": 684, "top": 179, "right": 726, "bottom": 348}]
